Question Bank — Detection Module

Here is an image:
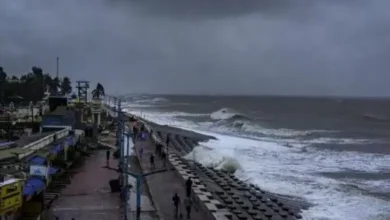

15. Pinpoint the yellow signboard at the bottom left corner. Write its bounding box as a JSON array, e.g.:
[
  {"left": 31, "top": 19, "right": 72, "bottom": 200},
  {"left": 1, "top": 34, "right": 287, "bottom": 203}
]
[{"left": 0, "top": 180, "right": 22, "bottom": 216}]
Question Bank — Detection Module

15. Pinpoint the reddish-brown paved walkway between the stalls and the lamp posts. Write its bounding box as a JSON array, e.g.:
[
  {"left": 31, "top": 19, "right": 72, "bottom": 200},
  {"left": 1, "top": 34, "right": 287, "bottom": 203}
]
[{"left": 49, "top": 151, "right": 123, "bottom": 220}]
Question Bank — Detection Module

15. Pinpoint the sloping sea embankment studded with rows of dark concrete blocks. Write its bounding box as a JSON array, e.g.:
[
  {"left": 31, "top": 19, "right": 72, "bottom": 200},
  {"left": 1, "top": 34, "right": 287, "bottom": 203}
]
[{"left": 106, "top": 105, "right": 310, "bottom": 219}]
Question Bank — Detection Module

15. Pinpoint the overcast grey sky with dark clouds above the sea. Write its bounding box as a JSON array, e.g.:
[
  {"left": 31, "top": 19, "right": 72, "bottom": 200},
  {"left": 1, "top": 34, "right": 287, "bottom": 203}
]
[{"left": 0, "top": 0, "right": 390, "bottom": 96}]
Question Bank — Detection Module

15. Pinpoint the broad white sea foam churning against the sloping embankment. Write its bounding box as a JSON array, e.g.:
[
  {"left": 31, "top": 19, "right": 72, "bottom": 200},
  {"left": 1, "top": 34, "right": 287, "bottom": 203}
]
[{"left": 120, "top": 103, "right": 390, "bottom": 220}]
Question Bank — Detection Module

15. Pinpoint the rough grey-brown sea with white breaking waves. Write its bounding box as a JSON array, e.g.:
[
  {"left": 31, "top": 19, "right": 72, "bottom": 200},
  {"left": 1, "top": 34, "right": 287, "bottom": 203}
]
[{"left": 116, "top": 95, "right": 390, "bottom": 220}]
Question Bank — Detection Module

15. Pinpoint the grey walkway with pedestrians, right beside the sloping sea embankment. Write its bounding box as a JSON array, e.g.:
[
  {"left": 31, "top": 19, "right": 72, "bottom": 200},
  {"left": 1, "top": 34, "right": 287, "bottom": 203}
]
[{"left": 135, "top": 132, "right": 208, "bottom": 220}]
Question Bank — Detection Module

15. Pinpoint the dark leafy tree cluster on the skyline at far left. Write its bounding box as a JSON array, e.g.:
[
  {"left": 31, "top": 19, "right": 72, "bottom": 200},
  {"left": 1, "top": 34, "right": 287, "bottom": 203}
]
[{"left": 0, "top": 66, "right": 72, "bottom": 103}]
